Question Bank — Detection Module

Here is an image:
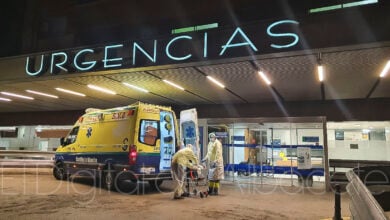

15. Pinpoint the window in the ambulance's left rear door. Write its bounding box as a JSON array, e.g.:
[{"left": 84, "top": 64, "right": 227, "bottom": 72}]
[{"left": 139, "top": 119, "right": 159, "bottom": 146}]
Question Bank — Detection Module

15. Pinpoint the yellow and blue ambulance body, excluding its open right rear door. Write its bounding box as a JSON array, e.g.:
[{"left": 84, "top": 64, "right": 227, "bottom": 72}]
[{"left": 53, "top": 102, "right": 180, "bottom": 190}]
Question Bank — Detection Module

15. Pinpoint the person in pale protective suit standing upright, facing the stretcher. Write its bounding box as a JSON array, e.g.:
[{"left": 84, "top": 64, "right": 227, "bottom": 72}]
[{"left": 202, "top": 133, "right": 224, "bottom": 195}]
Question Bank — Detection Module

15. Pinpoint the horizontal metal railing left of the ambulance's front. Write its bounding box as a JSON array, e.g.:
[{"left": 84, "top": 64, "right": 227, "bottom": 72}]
[{"left": 0, "top": 150, "right": 55, "bottom": 168}]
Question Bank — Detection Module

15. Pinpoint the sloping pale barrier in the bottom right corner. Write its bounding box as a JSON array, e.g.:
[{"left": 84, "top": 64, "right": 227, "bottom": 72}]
[{"left": 347, "top": 170, "right": 387, "bottom": 220}]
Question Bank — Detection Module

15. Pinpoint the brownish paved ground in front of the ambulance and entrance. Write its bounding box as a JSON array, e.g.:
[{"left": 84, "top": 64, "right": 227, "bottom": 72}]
[{"left": 0, "top": 169, "right": 350, "bottom": 220}]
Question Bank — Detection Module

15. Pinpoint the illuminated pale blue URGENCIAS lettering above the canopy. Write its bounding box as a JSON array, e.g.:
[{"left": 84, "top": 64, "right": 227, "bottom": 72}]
[{"left": 25, "top": 20, "right": 300, "bottom": 76}]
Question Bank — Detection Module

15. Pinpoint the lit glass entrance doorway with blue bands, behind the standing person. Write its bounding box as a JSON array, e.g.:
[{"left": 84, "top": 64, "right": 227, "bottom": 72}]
[{"left": 205, "top": 117, "right": 329, "bottom": 187}]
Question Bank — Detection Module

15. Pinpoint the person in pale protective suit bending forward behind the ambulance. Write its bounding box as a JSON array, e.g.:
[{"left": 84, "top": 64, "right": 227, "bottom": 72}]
[{"left": 171, "top": 144, "right": 200, "bottom": 199}]
